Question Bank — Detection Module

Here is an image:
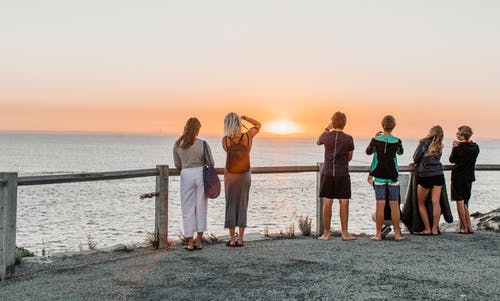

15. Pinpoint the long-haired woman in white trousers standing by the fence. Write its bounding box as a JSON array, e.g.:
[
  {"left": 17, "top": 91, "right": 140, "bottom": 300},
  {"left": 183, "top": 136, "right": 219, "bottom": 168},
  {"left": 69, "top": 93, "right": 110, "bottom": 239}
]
[{"left": 173, "top": 117, "right": 214, "bottom": 251}]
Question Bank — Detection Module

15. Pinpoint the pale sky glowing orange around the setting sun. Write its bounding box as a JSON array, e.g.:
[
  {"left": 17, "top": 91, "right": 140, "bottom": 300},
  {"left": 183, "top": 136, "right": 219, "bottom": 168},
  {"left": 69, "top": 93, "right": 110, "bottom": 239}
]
[{"left": 0, "top": 0, "right": 500, "bottom": 138}]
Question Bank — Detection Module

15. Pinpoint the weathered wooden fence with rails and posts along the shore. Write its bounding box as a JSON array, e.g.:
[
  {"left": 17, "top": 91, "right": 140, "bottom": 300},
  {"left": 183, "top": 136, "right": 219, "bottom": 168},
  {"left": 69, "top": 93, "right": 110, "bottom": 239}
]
[{"left": 0, "top": 164, "right": 500, "bottom": 280}]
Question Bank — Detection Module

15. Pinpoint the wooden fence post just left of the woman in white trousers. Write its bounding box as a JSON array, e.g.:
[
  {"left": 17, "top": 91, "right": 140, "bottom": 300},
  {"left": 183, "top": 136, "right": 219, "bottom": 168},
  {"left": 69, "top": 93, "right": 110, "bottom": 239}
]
[{"left": 155, "top": 165, "right": 168, "bottom": 248}]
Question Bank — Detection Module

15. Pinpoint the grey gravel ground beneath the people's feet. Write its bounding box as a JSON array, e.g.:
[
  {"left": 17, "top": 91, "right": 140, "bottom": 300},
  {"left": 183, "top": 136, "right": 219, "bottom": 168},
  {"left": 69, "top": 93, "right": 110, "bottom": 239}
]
[{"left": 0, "top": 232, "right": 500, "bottom": 300}]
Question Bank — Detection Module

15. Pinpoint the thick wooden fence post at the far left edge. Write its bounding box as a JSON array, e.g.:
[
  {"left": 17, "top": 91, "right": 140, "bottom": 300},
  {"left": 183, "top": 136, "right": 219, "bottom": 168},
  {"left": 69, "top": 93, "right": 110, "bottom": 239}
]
[{"left": 0, "top": 173, "right": 17, "bottom": 280}]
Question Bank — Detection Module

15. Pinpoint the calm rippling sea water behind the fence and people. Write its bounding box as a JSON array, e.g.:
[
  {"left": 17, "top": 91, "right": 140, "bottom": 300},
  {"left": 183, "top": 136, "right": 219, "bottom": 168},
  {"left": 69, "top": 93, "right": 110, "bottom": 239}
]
[{"left": 0, "top": 133, "right": 500, "bottom": 252}]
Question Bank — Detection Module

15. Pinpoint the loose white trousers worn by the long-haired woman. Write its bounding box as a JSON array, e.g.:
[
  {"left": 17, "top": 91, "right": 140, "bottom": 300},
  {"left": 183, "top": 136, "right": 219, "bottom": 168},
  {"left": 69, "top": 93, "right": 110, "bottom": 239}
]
[{"left": 181, "top": 167, "right": 208, "bottom": 237}]
